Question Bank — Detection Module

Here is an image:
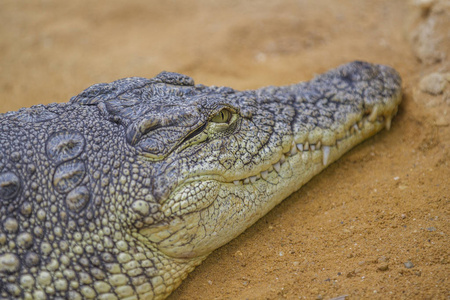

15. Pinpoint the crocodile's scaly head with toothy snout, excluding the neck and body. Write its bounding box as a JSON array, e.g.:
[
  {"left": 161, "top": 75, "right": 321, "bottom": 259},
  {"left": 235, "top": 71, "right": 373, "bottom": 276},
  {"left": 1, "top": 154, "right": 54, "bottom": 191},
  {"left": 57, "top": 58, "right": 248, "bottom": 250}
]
[{"left": 72, "top": 62, "right": 401, "bottom": 258}]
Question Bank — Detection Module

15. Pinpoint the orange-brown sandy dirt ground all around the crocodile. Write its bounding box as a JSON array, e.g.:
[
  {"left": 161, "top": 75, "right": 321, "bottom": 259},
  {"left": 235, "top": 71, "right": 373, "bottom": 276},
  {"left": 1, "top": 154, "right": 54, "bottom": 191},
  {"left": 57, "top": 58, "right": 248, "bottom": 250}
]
[{"left": 0, "top": 0, "right": 450, "bottom": 300}]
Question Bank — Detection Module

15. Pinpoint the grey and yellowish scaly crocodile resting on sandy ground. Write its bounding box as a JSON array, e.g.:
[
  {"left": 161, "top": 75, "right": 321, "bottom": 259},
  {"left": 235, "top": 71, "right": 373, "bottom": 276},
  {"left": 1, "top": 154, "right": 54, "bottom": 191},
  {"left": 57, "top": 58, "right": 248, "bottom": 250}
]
[{"left": 0, "top": 61, "right": 402, "bottom": 299}]
